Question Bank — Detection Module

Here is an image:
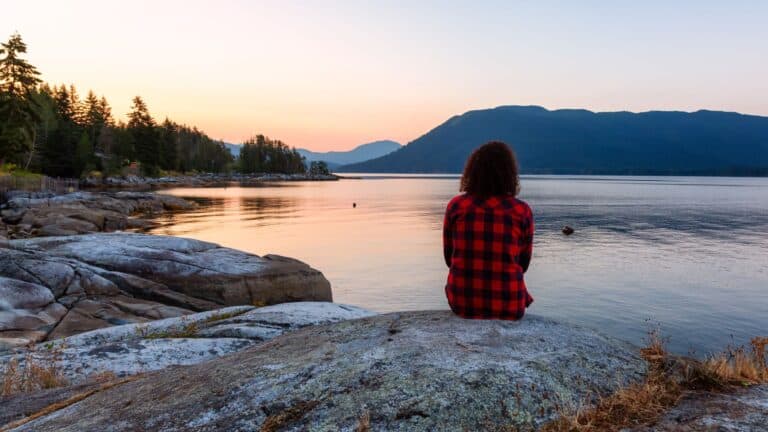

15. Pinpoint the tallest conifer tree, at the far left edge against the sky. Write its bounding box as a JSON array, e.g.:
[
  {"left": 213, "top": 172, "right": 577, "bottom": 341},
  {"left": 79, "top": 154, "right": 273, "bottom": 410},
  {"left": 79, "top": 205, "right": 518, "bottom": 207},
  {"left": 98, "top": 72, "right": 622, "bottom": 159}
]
[{"left": 0, "top": 33, "right": 40, "bottom": 164}]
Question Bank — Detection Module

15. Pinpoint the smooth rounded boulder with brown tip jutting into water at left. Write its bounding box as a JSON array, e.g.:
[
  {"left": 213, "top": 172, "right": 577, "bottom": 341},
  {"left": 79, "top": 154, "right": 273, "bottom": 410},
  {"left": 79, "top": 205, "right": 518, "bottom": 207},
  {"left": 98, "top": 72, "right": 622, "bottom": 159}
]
[{"left": 13, "top": 233, "right": 332, "bottom": 305}]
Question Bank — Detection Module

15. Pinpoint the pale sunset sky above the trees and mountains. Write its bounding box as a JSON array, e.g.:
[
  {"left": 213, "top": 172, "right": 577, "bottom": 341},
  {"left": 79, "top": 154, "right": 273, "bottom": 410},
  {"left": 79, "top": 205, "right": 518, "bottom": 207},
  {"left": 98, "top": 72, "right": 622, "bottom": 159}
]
[{"left": 0, "top": 0, "right": 768, "bottom": 150}]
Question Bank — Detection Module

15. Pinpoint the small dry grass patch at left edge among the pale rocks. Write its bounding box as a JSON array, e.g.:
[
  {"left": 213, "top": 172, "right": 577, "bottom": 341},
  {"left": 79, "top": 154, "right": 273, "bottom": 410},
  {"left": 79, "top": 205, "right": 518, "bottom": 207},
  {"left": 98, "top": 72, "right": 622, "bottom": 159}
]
[{"left": 0, "top": 349, "right": 67, "bottom": 396}]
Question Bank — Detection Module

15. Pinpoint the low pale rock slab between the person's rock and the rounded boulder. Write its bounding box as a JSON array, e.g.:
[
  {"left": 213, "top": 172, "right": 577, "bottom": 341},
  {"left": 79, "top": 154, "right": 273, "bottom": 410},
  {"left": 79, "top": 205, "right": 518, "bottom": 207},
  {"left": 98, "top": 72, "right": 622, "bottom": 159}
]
[{"left": 0, "top": 302, "right": 374, "bottom": 425}]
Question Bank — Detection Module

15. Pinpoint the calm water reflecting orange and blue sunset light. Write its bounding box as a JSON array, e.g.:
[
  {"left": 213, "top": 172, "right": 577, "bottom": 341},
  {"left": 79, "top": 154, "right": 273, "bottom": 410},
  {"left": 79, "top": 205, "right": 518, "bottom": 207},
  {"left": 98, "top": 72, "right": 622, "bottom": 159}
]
[{"left": 148, "top": 176, "right": 768, "bottom": 355}]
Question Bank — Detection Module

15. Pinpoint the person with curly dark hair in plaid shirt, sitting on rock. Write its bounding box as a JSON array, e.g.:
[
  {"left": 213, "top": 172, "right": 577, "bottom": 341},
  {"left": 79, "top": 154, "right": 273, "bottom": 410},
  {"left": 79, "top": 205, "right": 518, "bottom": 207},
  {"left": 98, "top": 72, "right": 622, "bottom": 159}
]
[{"left": 443, "top": 141, "right": 533, "bottom": 320}]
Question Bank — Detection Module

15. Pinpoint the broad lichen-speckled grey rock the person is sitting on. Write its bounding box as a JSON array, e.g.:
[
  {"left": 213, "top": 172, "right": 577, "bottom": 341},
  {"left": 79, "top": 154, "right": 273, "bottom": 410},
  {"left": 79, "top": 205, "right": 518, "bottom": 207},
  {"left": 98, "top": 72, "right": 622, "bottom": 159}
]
[{"left": 14, "top": 312, "right": 644, "bottom": 432}]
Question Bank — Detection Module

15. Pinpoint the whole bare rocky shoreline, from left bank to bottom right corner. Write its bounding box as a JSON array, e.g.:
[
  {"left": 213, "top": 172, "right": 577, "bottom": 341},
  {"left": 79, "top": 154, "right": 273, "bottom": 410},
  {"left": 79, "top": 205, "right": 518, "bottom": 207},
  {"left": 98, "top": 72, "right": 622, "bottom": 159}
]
[{"left": 0, "top": 191, "right": 768, "bottom": 431}]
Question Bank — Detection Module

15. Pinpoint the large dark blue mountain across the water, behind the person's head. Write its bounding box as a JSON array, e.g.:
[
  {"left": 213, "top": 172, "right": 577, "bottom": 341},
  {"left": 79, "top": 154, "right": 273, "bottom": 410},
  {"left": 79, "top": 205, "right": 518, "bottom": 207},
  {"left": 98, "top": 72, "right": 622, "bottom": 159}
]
[{"left": 339, "top": 106, "right": 768, "bottom": 175}]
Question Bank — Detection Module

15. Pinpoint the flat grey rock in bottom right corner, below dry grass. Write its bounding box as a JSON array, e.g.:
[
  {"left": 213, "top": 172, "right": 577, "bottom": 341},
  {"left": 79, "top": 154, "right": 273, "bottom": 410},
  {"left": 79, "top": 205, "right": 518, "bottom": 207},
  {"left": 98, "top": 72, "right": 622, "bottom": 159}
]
[{"left": 633, "top": 385, "right": 768, "bottom": 432}]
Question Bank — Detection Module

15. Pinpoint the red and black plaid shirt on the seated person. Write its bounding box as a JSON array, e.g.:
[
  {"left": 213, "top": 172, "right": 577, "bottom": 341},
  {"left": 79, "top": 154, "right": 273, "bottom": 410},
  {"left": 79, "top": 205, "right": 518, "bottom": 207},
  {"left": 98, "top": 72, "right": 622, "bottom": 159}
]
[{"left": 443, "top": 194, "right": 533, "bottom": 320}]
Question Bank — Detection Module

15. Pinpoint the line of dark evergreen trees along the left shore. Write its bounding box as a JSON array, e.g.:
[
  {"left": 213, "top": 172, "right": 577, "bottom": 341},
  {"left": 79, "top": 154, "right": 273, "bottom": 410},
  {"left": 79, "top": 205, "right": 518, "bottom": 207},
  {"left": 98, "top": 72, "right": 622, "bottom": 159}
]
[{"left": 0, "top": 33, "right": 306, "bottom": 177}]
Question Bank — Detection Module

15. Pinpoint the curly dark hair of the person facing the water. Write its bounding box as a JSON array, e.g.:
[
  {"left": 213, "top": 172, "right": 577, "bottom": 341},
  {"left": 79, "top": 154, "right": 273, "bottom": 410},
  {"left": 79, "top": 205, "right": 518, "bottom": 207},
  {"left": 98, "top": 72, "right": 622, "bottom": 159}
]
[{"left": 459, "top": 141, "right": 520, "bottom": 197}]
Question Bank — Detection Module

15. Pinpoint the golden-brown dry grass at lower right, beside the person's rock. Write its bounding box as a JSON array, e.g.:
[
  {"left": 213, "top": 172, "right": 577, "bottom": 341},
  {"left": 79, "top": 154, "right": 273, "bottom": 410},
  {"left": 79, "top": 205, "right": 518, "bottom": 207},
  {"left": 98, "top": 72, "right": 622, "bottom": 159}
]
[{"left": 541, "top": 332, "right": 768, "bottom": 432}]
